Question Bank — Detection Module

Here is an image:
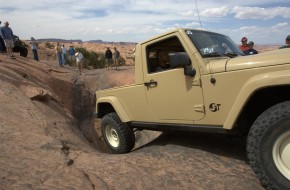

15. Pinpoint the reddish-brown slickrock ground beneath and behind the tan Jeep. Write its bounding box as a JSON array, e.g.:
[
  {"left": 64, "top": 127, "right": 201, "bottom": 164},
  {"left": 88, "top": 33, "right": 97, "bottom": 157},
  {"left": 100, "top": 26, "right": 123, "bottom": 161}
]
[{"left": 0, "top": 54, "right": 263, "bottom": 190}]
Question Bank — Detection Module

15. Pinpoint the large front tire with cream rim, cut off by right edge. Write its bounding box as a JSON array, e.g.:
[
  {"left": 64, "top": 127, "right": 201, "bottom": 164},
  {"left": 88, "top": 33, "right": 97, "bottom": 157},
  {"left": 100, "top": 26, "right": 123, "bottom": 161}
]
[{"left": 247, "top": 101, "right": 290, "bottom": 190}]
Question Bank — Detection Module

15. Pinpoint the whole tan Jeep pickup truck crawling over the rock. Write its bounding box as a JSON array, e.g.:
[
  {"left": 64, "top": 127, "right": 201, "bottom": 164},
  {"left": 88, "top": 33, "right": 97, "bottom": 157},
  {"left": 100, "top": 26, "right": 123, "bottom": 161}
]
[{"left": 96, "top": 29, "right": 290, "bottom": 189}]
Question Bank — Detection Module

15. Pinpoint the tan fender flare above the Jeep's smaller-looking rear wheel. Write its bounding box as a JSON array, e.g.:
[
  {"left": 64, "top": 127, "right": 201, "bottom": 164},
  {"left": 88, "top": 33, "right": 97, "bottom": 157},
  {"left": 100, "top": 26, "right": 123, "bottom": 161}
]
[{"left": 96, "top": 96, "right": 131, "bottom": 122}]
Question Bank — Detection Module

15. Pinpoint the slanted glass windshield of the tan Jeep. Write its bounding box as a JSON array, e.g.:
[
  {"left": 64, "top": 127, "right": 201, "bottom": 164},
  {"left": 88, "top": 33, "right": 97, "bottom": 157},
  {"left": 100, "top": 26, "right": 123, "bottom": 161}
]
[{"left": 185, "top": 30, "right": 244, "bottom": 58}]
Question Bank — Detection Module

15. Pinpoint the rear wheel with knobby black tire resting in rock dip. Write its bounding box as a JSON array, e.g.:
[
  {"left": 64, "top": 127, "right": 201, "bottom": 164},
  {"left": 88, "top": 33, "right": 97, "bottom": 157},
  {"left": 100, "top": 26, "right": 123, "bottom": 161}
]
[{"left": 101, "top": 113, "right": 135, "bottom": 154}]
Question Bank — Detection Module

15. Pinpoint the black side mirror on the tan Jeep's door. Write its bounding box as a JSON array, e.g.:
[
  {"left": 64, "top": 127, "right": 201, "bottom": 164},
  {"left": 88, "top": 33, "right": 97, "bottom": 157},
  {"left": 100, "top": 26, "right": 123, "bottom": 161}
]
[{"left": 169, "top": 52, "right": 196, "bottom": 77}]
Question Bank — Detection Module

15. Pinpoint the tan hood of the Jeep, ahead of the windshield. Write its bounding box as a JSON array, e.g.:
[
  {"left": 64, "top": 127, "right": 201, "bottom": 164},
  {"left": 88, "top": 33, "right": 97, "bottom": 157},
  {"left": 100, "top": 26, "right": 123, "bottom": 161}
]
[{"left": 209, "top": 48, "right": 290, "bottom": 73}]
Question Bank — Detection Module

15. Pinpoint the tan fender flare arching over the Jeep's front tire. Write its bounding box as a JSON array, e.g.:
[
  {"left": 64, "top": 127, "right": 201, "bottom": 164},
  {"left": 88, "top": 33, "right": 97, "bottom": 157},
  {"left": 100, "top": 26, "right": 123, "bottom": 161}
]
[{"left": 223, "top": 70, "right": 290, "bottom": 129}]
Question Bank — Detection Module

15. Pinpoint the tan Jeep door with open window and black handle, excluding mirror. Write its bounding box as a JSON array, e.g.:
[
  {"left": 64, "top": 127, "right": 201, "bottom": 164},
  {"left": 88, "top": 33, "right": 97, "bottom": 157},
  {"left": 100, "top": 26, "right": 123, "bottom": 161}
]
[{"left": 142, "top": 33, "right": 205, "bottom": 123}]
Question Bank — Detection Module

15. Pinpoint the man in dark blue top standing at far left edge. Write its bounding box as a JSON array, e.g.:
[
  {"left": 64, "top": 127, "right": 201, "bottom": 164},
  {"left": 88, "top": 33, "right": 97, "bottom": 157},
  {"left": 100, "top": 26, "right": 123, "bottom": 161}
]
[{"left": 1, "top": 21, "right": 15, "bottom": 59}]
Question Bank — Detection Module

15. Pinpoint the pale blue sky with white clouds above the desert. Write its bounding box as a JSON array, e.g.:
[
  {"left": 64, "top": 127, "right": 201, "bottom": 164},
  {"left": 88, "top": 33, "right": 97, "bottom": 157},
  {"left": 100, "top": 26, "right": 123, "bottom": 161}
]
[{"left": 0, "top": 0, "right": 290, "bottom": 45}]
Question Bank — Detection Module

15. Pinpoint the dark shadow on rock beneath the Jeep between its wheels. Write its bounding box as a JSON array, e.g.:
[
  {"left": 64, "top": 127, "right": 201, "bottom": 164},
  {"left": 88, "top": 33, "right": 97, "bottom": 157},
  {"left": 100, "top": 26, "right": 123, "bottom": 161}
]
[{"left": 134, "top": 132, "right": 247, "bottom": 162}]
